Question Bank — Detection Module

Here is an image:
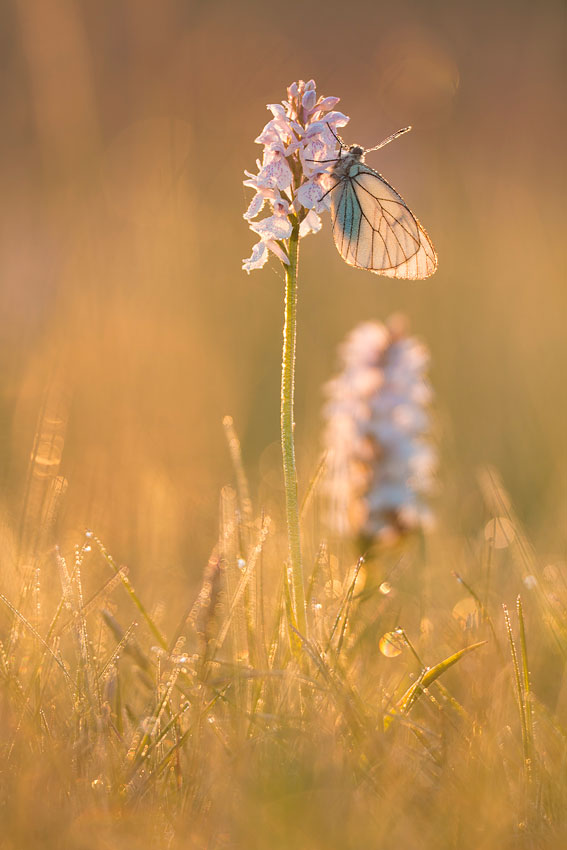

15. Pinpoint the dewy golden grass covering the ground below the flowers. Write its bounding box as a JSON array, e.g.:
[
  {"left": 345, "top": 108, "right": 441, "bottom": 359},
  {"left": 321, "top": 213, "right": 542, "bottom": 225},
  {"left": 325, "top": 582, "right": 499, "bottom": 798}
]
[{"left": 0, "top": 420, "right": 567, "bottom": 850}]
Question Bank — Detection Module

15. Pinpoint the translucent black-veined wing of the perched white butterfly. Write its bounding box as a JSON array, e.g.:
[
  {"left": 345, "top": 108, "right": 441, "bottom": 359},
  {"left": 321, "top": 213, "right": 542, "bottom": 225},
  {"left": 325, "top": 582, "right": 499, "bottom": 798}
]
[{"left": 331, "top": 163, "right": 437, "bottom": 279}]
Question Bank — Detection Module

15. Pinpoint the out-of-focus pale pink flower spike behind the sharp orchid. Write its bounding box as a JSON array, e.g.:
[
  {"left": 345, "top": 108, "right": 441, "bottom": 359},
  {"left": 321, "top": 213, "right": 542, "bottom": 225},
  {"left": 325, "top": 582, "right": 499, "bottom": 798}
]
[{"left": 324, "top": 317, "right": 437, "bottom": 541}]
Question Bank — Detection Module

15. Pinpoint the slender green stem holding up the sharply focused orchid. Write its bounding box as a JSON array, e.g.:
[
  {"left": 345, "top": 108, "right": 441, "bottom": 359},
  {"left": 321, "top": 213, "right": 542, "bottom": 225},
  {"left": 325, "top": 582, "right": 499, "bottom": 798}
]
[{"left": 281, "top": 222, "right": 306, "bottom": 636}]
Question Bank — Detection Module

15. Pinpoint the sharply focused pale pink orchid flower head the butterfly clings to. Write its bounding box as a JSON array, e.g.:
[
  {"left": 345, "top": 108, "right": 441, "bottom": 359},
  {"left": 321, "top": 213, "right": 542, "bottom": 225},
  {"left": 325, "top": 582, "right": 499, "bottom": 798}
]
[{"left": 242, "top": 80, "right": 349, "bottom": 272}]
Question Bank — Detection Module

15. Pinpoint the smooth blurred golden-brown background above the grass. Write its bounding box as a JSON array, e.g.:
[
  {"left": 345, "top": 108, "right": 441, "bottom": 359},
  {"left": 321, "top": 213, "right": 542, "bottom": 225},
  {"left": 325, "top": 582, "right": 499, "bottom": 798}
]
[{"left": 0, "top": 0, "right": 567, "bottom": 591}]
